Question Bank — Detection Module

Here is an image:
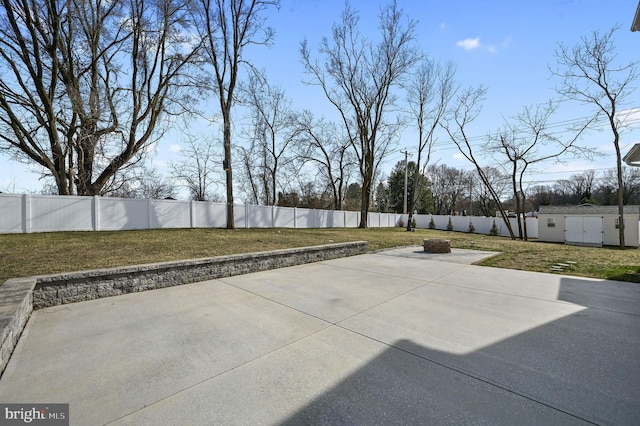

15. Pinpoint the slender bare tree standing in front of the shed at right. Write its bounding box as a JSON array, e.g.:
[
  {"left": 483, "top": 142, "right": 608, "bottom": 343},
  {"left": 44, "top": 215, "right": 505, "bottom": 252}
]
[{"left": 553, "top": 27, "right": 638, "bottom": 248}]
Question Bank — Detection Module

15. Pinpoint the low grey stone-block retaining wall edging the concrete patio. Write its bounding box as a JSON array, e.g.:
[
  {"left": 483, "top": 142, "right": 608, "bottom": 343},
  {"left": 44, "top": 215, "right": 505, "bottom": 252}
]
[{"left": 0, "top": 241, "right": 367, "bottom": 374}]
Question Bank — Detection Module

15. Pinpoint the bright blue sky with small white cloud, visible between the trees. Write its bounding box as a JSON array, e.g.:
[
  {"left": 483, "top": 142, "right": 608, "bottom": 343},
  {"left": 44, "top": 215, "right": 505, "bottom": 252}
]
[{"left": 0, "top": 0, "right": 640, "bottom": 193}]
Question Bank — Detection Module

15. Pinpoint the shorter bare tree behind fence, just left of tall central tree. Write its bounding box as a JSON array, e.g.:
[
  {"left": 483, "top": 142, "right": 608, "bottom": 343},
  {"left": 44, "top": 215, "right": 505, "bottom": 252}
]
[{"left": 296, "top": 111, "right": 356, "bottom": 210}]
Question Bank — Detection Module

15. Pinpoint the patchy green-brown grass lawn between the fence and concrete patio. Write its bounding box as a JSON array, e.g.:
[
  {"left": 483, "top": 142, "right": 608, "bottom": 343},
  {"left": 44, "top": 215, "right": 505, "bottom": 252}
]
[{"left": 0, "top": 228, "right": 640, "bottom": 282}]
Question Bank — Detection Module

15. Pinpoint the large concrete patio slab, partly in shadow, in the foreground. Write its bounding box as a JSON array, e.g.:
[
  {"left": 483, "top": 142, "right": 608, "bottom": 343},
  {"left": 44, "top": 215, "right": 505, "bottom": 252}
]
[{"left": 0, "top": 247, "right": 640, "bottom": 425}]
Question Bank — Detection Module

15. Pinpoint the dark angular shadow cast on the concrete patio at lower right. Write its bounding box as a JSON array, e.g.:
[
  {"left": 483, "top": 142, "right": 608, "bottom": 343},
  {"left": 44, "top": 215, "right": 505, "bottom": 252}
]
[{"left": 282, "top": 277, "right": 640, "bottom": 425}]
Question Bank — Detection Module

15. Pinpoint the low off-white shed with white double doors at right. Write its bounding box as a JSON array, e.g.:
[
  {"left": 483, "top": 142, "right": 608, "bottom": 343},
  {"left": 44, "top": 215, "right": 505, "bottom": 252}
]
[{"left": 538, "top": 204, "right": 640, "bottom": 247}]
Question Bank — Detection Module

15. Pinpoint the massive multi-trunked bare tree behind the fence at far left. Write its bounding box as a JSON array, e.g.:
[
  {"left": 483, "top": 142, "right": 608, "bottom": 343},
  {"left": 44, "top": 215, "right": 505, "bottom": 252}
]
[{"left": 0, "top": 0, "right": 198, "bottom": 195}]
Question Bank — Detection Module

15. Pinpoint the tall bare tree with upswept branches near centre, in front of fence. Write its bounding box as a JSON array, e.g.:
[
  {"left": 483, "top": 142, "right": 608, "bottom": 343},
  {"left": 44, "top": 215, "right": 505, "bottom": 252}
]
[{"left": 300, "top": 1, "right": 421, "bottom": 228}]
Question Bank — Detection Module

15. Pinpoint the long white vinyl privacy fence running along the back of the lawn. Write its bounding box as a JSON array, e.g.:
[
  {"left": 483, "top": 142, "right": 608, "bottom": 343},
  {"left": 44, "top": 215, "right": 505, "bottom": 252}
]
[{"left": 0, "top": 194, "right": 538, "bottom": 238}]
